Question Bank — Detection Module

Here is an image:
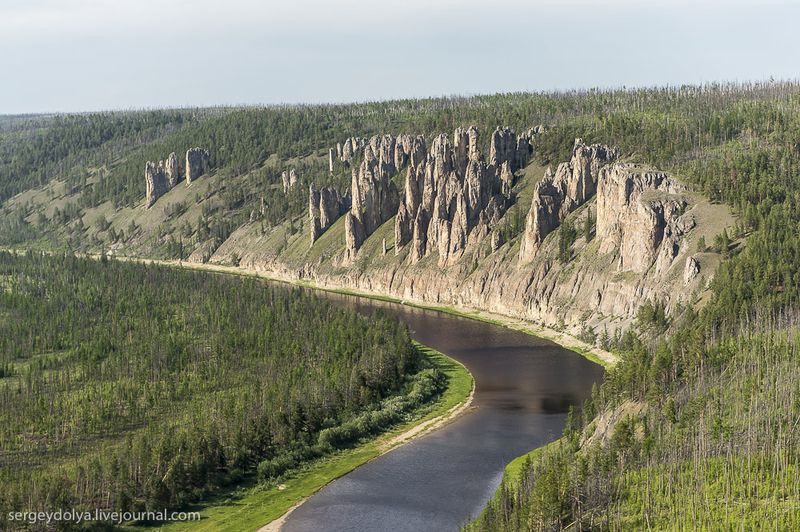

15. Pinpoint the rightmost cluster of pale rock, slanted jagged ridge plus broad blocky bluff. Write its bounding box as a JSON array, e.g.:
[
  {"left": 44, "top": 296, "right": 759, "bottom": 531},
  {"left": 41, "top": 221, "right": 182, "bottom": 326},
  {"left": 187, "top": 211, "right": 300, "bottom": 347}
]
[{"left": 519, "top": 139, "right": 699, "bottom": 276}]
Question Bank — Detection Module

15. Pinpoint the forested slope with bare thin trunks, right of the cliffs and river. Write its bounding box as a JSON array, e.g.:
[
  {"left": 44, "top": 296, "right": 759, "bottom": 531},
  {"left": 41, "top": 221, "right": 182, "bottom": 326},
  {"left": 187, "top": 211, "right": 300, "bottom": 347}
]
[{"left": 468, "top": 86, "right": 800, "bottom": 530}]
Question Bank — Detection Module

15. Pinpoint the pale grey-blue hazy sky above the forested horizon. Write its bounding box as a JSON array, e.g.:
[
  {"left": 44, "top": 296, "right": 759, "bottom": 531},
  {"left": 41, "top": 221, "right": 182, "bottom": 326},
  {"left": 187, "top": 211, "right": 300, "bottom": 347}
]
[{"left": 0, "top": 0, "right": 800, "bottom": 114}]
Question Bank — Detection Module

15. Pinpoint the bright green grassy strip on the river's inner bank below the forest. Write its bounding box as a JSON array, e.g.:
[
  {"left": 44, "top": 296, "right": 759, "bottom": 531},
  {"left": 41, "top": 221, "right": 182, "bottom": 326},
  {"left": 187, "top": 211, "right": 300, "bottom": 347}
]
[{"left": 129, "top": 344, "right": 474, "bottom": 531}]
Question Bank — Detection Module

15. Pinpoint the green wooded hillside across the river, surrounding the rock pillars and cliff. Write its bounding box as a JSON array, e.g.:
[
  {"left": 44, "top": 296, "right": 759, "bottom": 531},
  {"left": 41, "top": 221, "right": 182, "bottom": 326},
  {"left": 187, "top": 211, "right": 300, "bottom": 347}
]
[{"left": 0, "top": 82, "right": 800, "bottom": 530}]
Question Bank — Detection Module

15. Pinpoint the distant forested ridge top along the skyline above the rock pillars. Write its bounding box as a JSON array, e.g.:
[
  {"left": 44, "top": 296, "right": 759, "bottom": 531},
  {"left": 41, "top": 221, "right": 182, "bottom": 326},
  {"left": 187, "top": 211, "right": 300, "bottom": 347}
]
[{"left": 0, "top": 82, "right": 800, "bottom": 212}]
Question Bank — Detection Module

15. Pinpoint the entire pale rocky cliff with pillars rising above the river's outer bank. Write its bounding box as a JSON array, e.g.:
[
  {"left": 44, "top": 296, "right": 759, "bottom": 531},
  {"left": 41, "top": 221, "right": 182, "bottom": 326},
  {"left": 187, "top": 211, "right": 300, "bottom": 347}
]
[{"left": 197, "top": 135, "right": 733, "bottom": 334}]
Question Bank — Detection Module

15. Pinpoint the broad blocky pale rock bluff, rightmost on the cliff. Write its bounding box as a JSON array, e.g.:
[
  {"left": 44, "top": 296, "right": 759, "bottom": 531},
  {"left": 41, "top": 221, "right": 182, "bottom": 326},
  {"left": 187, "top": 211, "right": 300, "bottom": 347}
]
[{"left": 597, "top": 163, "right": 694, "bottom": 273}]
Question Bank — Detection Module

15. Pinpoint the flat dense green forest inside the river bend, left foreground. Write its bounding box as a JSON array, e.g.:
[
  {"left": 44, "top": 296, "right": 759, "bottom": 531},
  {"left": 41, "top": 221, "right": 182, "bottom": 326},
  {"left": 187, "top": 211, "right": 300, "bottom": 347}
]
[{"left": 0, "top": 252, "right": 444, "bottom": 524}]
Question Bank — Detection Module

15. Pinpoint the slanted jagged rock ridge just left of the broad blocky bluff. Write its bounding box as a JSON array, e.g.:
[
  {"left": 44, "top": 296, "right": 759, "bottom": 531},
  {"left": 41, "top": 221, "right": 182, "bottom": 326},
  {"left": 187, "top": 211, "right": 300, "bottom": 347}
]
[{"left": 519, "top": 139, "right": 617, "bottom": 262}]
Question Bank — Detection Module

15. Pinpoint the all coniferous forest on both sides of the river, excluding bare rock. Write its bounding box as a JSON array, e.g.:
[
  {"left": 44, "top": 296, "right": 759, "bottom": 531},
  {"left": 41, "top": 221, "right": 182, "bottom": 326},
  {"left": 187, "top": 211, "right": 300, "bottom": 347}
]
[{"left": 0, "top": 82, "right": 800, "bottom": 530}]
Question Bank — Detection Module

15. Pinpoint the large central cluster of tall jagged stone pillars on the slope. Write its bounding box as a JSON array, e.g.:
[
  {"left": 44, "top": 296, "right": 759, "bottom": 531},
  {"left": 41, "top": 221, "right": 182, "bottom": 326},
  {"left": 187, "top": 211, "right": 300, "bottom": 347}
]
[{"left": 337, "top": 126, "right": 533, "bottom": 265}]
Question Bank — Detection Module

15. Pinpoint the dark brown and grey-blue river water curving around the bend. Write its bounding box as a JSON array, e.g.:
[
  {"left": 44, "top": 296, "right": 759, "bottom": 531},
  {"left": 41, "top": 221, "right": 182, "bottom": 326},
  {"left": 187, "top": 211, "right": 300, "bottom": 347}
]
[{"left": 284, "top": 294, "right": 603, "bottom": 531}]
